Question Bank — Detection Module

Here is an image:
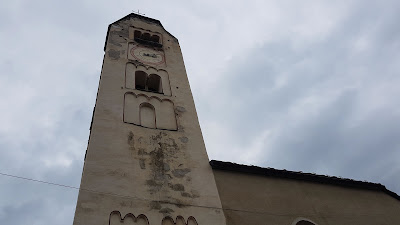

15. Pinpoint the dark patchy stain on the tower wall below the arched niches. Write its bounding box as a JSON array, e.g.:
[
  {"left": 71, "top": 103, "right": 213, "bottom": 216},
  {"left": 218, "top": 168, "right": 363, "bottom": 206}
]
[{"left": 127, "top": 131, "right": 199, "bottom": 205}]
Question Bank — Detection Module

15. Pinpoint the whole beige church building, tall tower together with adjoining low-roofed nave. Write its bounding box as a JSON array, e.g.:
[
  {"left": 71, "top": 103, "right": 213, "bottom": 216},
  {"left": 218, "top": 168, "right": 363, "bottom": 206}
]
[{"left": 74, "top": 13, "right": 400, "bottom": 225}]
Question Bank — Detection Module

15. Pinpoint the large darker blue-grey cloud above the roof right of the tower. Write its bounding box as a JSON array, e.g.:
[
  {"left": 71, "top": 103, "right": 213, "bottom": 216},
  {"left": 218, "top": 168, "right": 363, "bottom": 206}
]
[{"left": 205, "top": 0, "right": 400, "bottom": 192}]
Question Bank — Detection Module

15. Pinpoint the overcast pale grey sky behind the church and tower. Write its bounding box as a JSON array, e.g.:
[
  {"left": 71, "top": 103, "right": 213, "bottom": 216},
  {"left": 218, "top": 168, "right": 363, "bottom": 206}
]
[{"left": 0, "top": 0, "right": 400, "bottom": 225}]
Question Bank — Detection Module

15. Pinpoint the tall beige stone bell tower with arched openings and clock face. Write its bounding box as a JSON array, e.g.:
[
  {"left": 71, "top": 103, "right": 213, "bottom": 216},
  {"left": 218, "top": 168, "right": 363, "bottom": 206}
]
[{"left": 74, "top": 13, "right": 226, "bottom": 225}]
